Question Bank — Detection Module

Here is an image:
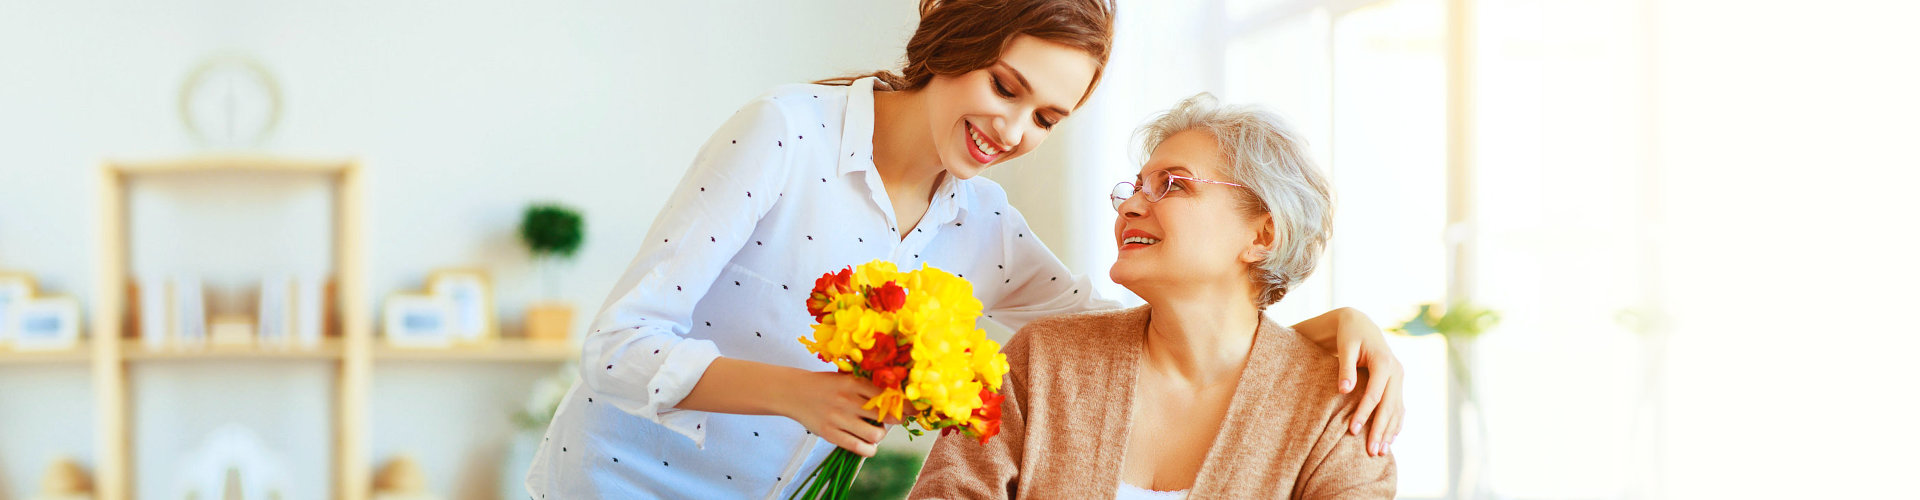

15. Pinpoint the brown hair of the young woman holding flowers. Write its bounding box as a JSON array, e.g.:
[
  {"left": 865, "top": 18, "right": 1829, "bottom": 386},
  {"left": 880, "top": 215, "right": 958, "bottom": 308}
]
[{"left": 816, "top": 0, "right": 1114, "bottom": 108}]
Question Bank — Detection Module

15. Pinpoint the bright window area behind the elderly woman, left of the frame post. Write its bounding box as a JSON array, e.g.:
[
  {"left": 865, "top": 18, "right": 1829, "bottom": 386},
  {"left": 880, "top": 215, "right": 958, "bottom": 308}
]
[{"left": 1223, "top": 0, "right": 1450, "bottom": 498}]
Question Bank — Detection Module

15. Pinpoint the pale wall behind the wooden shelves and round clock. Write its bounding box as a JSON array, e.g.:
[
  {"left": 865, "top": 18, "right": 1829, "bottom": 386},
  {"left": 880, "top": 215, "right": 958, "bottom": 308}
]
[{"left": 0, "top": 0, "right": 918, "bottom": 498}]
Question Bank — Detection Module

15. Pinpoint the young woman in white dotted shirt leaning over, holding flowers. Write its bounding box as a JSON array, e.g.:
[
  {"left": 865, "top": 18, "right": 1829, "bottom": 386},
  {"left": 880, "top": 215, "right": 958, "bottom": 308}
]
[{"left": 528, "top": 0, "right": 1400, "bottom": 498}]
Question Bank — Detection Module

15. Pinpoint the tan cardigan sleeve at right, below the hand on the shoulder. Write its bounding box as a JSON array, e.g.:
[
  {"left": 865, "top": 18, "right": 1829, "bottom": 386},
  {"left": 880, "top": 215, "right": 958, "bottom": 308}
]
[{"left": 1292, "top": 371, "right": 1398, "bottom": 498}]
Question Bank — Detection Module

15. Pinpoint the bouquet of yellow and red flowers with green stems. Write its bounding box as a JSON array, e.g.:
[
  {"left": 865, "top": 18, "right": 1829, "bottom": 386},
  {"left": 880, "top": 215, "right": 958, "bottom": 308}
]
[{"left": 789, "top": 260, "right": 1008, "bottom": 498}]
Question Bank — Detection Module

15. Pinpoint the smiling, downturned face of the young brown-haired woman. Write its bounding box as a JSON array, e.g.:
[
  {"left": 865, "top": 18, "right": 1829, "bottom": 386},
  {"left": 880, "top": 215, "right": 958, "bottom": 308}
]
[{"left": 925, "top": 35, "right": 1094, "bottom": 179}]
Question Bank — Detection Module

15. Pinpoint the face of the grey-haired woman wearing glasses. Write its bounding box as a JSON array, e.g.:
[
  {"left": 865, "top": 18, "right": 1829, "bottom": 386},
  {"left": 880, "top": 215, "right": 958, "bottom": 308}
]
[{"left": 1112, "top": 131, "right": 1265, "bottom": 296}]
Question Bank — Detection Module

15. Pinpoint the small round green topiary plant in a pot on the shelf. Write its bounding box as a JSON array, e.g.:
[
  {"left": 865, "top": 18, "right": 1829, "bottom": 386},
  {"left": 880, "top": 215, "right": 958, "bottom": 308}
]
[{"left": 520, "top": 204, "right": 586, "bottom": 342}]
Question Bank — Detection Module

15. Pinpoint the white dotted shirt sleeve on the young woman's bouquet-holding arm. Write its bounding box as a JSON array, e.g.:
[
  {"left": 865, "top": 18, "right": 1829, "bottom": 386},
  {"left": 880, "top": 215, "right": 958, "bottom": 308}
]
[{"left": 580, "top": 96, "right": 791, "bottom": 446}]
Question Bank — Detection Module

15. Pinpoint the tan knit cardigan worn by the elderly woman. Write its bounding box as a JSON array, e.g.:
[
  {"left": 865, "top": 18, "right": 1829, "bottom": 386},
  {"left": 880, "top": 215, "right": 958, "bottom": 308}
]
[{"left": 910, "top": 306, "right": 1394, "bottom": 498}]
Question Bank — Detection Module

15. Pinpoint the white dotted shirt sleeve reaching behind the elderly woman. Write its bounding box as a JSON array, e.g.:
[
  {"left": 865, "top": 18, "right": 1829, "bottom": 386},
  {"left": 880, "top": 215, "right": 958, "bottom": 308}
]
[{"left": 987, "top": 206, "right": 1121, "bottom": 331}]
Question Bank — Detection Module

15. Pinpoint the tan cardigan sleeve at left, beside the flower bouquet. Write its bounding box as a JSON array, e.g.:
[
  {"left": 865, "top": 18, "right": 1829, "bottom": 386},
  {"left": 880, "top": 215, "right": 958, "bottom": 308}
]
[{"left": 908, "top": 335, "right": 1031, "bottom": 498}]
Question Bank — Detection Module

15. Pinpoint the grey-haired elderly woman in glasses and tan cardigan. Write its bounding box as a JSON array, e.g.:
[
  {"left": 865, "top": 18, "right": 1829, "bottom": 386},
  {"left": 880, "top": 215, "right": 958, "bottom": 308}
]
[{"left": 912, "top": 94, "right": 1394, "bottom": 498}]
